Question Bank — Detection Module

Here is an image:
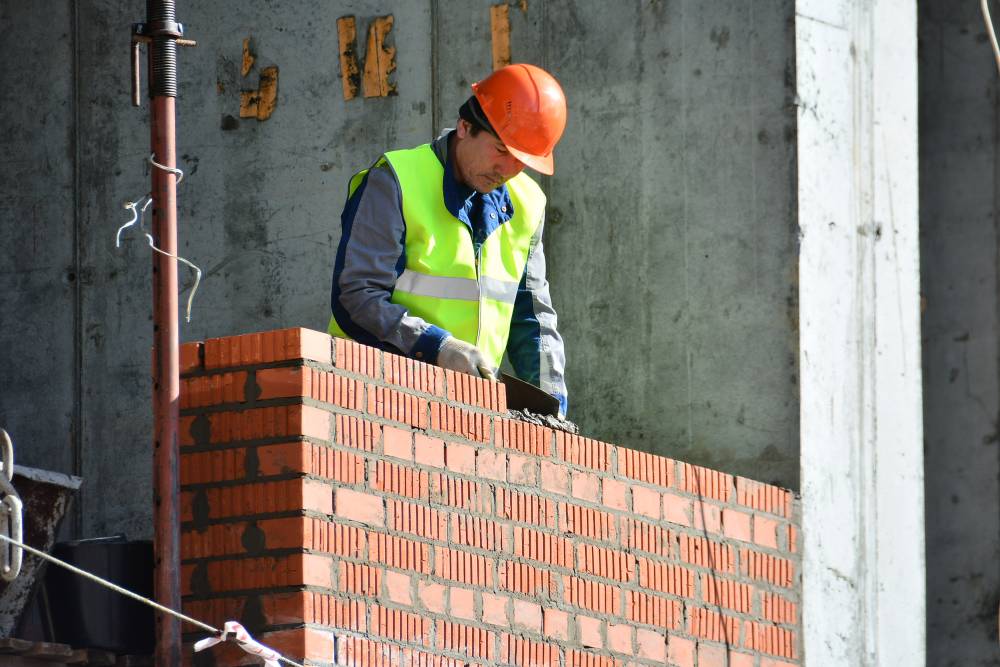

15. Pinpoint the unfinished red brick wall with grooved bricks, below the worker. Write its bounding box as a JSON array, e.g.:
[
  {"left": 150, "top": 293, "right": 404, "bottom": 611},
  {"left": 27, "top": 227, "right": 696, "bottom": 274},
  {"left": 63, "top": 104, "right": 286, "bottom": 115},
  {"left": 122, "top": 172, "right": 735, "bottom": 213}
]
[{"left": 181, "top": 329, "right": 801, "bottom": 667}]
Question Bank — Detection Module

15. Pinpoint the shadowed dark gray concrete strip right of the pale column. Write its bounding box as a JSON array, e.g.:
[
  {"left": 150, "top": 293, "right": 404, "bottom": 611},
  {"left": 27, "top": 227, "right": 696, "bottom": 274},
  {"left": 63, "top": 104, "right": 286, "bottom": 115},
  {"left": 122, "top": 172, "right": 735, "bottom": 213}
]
[{"left": 919, "top": 0, "right": 1000, "bottom": 667}]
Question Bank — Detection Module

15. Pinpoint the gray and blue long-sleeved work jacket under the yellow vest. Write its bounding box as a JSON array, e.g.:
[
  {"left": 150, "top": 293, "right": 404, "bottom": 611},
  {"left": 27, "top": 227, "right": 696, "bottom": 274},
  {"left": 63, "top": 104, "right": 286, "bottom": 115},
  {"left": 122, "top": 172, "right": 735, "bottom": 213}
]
[{"left": 331, "top": 130, "right": 567, "bottom": 413}]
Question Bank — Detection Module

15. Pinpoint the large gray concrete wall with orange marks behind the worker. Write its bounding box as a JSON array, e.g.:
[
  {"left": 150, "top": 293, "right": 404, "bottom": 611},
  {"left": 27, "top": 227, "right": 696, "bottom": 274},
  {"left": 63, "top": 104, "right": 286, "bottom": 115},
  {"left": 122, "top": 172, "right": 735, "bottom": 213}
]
[{"left": 0, "top": 0, "right": 798, "bottom": 535}]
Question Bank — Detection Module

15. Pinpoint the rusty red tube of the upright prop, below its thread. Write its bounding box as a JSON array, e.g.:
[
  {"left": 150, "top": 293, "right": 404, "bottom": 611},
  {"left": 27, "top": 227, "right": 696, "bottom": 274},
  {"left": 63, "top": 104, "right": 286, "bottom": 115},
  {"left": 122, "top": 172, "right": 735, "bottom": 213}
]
[{"left": 150, "top": 83, "right": 181, "bottom": 667}]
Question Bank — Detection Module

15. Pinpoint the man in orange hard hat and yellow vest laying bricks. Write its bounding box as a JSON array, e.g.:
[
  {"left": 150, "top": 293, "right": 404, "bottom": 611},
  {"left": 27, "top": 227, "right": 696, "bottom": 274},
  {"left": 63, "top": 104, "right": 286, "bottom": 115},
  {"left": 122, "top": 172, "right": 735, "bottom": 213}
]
[{"left": 329, "top": 64, "right": 567, "bottom": 415}]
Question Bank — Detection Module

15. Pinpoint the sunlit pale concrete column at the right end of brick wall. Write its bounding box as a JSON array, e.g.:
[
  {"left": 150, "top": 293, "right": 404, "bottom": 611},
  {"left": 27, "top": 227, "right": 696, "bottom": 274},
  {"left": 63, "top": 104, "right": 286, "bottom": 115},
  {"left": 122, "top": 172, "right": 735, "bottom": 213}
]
[{"left": 795, "top": 0, "right": 925, "bottom": 666}]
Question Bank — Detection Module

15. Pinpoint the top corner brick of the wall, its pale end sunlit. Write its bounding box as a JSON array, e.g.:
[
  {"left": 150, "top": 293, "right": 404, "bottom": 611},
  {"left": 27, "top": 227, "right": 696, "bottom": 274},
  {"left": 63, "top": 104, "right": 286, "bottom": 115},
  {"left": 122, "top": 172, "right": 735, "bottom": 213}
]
[{"left": 204, "top": 328, "right": 331, "bottom": 369}]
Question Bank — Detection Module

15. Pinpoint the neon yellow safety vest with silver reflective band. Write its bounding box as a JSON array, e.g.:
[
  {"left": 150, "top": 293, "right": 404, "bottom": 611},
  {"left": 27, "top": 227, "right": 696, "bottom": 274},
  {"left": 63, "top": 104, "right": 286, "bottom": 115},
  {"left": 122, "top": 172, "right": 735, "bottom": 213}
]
[{"left": 328, "top": 144, "right": 545, "bottom": 366}]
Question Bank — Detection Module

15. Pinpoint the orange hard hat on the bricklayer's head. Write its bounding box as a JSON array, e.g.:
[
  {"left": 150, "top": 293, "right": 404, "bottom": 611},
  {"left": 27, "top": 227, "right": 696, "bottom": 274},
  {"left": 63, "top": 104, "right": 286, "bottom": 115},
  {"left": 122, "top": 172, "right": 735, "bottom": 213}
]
[{"left": 472, "top": 64, "right": 566, "bottom": 174}]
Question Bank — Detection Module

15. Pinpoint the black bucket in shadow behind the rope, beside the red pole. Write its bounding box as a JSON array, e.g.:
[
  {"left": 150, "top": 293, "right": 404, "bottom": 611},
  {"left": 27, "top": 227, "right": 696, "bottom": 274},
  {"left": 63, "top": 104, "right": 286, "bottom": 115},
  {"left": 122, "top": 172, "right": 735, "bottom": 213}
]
[{"left": 45, "top": 535, "right": 155, "bottom": 655}]
